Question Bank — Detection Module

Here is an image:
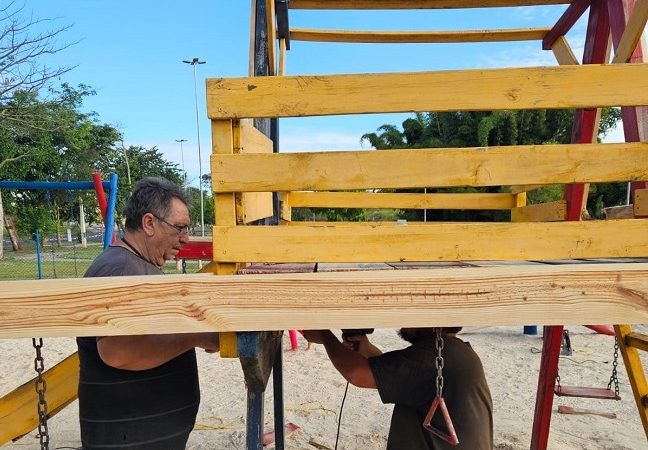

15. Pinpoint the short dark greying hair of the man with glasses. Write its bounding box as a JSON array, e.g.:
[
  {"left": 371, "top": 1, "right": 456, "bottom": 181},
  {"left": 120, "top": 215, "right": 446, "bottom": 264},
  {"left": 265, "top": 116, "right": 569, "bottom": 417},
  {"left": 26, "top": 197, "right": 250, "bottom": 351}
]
[{"left": 124, "top": 177, "right": 189, "bottom": 231}]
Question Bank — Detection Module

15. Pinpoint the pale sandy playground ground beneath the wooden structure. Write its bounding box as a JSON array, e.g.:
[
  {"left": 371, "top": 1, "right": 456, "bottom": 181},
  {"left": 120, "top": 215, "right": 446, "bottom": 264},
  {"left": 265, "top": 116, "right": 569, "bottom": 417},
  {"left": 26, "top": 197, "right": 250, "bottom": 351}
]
[{"left": 0, "top": 326, "right": 648, "bottom": 450}]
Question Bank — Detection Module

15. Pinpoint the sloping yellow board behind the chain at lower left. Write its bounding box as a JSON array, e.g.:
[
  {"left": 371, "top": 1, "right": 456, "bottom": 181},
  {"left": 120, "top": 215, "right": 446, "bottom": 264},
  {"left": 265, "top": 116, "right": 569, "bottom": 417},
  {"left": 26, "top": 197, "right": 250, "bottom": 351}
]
[{"left": 0, "top": 353, "right": 79, "bottom": 445}]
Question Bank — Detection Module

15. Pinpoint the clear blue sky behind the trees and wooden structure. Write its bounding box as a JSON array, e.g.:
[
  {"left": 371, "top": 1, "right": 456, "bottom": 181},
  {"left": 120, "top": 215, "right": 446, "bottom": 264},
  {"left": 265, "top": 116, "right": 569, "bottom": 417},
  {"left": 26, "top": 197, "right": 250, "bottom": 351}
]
[{"left": 25, "top": 0, "right": 640, "bottom": 186}]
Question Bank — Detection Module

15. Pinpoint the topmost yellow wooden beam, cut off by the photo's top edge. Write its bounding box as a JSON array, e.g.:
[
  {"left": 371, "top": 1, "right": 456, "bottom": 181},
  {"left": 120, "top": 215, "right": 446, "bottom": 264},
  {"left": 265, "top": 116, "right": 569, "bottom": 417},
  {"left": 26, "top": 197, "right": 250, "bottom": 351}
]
[{"left": 288, "top": 0, "right": 571, "bottom": 9}]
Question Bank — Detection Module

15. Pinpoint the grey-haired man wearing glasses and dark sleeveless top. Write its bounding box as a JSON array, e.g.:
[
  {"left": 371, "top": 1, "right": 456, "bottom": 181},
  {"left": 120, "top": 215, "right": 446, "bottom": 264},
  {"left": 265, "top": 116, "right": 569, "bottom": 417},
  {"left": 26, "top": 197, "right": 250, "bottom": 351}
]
[{"left": 77, "top": 178, "right": 219, "bottom": 450}]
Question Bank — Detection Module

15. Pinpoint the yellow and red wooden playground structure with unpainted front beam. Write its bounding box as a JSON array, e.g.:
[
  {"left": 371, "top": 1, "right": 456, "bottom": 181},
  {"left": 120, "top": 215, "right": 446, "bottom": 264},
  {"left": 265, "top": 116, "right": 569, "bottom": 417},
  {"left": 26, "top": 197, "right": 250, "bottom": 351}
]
[{"left": 0, "top": 0, "right": 648, "bottom": 450}]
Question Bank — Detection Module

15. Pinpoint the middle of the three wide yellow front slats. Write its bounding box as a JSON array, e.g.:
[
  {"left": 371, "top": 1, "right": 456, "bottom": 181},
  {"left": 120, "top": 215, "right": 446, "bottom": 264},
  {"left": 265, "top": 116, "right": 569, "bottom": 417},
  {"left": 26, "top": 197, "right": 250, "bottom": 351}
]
[{"left": 211, "top": 142, "right": 648, "bottom": 193}]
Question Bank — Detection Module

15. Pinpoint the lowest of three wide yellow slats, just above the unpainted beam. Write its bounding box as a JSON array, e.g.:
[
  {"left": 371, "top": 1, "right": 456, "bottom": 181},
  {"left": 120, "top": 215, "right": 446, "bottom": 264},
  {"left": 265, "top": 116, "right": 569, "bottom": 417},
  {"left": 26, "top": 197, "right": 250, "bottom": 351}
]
[{"left": 213, "top": 219, "right": 648, "bottom": 263}]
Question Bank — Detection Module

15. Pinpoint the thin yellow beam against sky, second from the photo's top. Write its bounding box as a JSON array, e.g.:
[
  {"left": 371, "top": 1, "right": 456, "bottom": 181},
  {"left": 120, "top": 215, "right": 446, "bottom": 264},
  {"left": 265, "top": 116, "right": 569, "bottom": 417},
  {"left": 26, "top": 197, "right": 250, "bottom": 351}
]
[{"left": 290, "top": 28, "right": 551, "bottom": 44}]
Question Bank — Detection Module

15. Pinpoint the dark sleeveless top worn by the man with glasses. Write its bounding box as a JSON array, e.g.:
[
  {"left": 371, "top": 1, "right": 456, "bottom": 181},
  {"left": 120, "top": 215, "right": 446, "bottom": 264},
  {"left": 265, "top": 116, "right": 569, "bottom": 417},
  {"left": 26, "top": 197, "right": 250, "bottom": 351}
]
[{"left": 77, "top": 247, "right": 200, "bottom": 450}]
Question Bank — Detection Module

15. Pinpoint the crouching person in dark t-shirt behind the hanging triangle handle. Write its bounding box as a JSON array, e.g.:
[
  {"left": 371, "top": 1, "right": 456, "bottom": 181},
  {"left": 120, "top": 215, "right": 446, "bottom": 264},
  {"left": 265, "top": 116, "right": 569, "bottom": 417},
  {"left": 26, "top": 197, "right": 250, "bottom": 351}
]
[{"left": 304, "top": 327, "right": 493, "bottom": 450}]
